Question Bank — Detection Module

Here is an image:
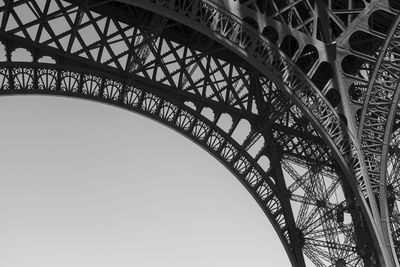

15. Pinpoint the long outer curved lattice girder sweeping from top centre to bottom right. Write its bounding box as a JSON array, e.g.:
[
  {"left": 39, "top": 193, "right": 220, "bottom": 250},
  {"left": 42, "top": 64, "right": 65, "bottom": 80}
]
[{"left": 122, "top": 0, "right": 394, "bottom": 264}]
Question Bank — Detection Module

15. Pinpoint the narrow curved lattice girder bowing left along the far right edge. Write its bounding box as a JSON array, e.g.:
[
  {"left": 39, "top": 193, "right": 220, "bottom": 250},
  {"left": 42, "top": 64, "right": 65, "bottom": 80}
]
[{"left": 359, "top": 9, "right": 400, "bottom": 266}]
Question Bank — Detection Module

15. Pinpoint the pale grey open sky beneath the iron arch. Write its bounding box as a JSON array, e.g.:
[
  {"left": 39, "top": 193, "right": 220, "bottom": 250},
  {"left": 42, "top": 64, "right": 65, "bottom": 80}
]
[{"left": 0, "top": 96, "right": 290, "bottom": 267}]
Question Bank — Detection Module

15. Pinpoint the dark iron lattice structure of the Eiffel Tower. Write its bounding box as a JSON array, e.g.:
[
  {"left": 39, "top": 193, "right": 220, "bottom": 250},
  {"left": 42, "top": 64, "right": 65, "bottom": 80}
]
[{"left": 0, "top": 0, "right": 400, "bottom": 267}]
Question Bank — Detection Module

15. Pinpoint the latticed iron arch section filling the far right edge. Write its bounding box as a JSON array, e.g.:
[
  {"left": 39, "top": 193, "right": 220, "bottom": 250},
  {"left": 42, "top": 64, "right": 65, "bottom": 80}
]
[{"left": 342, "top": 1, "right": 400, "bottom": 264}]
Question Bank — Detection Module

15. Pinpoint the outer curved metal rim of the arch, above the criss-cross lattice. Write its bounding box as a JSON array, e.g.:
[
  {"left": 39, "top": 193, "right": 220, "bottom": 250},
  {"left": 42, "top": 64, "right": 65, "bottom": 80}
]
[{"left": 112, "top": 0, "right": 386, "bottom": 261}]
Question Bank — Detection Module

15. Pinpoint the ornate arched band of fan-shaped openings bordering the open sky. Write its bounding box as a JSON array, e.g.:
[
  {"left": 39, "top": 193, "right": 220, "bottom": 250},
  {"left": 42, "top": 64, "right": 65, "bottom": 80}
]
[{"left": 0, "top": 62, "right": 305, "bottom": 266}]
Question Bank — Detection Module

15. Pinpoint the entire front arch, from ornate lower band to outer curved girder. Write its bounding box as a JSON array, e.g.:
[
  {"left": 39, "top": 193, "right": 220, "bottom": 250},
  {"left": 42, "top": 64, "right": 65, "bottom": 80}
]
[{"left": 0, "top": 0, "right": 397, "bottom": 267}]
